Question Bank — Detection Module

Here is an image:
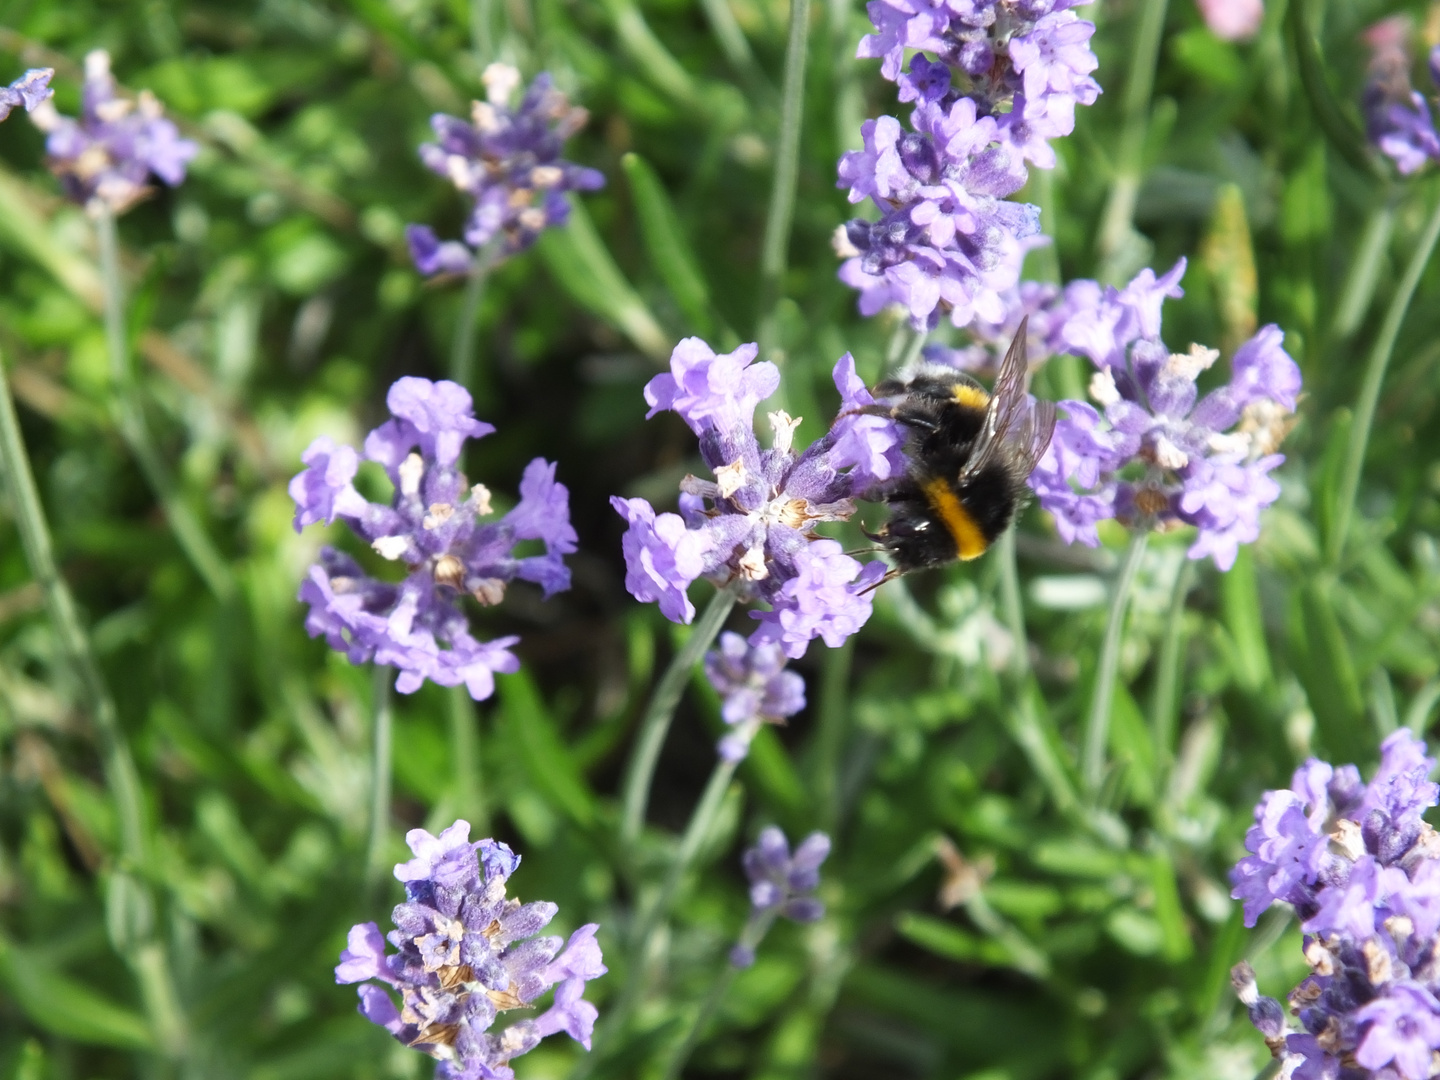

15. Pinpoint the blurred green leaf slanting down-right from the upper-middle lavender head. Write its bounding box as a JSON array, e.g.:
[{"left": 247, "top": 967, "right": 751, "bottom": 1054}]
[{"left": 536, "top": 199, "right": 671, "bottom": 360}]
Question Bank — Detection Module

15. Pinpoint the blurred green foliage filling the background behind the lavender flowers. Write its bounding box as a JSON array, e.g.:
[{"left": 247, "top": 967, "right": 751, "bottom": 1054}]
[{"left": 0, "top": 0, "right": 1440, "bottom": 1080}]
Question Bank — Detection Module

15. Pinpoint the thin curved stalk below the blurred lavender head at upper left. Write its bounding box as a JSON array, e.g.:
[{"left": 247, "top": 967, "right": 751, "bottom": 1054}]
[{"left": 95, "top": 204, "right": 235, "bottom": 600}]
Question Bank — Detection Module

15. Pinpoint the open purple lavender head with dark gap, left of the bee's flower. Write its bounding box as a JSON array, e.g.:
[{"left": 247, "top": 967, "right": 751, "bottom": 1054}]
[{"left": 289, "top": 377, "right": 576, "bottom": 701}]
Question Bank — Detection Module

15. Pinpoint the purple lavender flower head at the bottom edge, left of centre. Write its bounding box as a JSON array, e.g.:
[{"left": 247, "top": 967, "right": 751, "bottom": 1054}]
[{"left": 336, "top": 821, "right": 606, "bottom": 1080}]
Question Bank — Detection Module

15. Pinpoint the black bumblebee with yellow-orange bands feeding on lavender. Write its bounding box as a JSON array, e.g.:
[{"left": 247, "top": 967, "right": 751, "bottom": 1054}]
[{"left": 865, "top": 318, "right": 1056, "bottom": 580}]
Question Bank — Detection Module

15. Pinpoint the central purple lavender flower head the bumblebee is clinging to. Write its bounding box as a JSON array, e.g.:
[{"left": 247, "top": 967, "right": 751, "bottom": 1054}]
[{"left": 611, "top": 337, "right": 904, "bottom": 658}]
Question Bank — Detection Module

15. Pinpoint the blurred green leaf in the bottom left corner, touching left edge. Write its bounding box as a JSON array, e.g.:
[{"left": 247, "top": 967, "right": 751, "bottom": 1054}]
[{"left": 0, "top": 937, "right": 154, "bottom": 1050}]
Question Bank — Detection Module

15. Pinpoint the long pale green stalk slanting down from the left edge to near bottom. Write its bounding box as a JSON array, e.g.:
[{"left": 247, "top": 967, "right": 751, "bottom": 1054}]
[{"left": 0, "top": 355, "right": 186, "bottom": 1057}]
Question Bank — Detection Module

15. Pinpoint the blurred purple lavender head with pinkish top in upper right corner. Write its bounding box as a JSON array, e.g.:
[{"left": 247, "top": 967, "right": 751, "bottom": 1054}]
[{"left": 1361, "top": 16, "right": 1440, "bottom": 176}]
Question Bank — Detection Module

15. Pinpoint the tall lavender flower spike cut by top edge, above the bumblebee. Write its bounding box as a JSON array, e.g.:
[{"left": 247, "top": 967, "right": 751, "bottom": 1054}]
[{"left": 835, "top": 0, "right": 1100, "bottom": 328}]
